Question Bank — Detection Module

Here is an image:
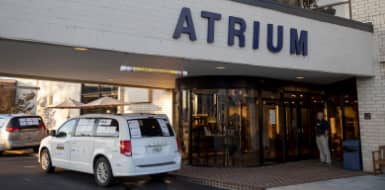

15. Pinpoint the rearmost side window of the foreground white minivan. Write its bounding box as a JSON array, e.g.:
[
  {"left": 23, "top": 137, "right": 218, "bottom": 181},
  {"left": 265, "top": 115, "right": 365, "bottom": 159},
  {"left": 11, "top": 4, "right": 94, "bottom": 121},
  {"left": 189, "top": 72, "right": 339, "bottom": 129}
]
[{"left": 95, "top": 118, "right": 119, "bottom": 137}]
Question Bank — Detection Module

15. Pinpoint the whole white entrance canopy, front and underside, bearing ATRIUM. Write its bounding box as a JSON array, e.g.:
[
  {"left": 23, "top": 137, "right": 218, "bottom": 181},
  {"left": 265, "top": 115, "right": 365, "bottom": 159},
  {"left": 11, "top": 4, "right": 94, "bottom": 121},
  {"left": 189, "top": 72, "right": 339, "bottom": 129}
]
[{"left": 0, "top": 0, "right": 374, "bottom": 88}]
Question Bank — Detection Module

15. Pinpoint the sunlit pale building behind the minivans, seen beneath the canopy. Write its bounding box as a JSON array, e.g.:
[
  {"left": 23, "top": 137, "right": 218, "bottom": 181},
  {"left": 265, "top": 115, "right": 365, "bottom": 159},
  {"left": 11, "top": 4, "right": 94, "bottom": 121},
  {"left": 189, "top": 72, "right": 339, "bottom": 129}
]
[{"left": 0, "top": 77, "right": 173, "bottom": 129}]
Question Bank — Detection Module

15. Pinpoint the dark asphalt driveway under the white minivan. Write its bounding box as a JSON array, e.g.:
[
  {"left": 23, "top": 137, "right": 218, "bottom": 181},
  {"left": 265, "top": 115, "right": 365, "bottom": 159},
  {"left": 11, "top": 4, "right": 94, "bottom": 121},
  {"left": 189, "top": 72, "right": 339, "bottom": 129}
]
[{"left": 0, "top": 152, "right": 220, "bottom": 190}]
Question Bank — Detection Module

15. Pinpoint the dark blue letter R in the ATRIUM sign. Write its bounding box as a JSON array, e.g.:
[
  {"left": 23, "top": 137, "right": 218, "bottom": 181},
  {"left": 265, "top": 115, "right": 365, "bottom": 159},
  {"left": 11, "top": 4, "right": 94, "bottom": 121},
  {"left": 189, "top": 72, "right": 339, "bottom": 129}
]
[{"left": 227, "top": 16, "right": 246, "bottom": 47}]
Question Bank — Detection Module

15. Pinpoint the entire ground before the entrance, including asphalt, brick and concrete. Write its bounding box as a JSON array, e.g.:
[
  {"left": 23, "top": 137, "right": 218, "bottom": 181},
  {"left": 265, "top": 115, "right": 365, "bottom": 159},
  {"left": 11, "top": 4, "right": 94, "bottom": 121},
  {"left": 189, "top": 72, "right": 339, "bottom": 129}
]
[{"left": 0, "top": 151, "right": 385, "bottom": 190}]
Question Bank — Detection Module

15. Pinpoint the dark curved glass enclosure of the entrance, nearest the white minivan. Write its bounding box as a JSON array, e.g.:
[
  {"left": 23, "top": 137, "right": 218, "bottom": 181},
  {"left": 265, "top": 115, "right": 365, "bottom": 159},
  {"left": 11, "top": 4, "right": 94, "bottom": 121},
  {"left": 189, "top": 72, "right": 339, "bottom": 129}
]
[{"left": 190, "top": 89, "right": 260, "bottom": 166}]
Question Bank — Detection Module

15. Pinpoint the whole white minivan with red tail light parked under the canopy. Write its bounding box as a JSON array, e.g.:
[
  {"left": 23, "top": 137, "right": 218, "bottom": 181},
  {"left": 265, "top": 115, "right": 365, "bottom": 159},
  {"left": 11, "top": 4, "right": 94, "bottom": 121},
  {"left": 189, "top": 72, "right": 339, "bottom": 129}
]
[{"left": 39, "top": 114, "right": 181, "bottom": 186}]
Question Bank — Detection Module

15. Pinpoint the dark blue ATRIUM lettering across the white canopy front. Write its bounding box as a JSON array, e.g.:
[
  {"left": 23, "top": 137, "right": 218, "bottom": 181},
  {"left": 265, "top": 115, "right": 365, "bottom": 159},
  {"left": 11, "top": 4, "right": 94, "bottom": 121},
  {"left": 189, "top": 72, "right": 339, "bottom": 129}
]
[{"left": 173, "top": 7, "right": 308, "bottom": 56}]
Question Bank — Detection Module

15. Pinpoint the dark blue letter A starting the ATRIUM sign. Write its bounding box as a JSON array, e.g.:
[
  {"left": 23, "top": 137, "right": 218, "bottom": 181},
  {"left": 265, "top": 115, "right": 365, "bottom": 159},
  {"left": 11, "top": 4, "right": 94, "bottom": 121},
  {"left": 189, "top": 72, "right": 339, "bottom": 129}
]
[{"left": 172, "top": 7, "right": 197, "bottom": 41}]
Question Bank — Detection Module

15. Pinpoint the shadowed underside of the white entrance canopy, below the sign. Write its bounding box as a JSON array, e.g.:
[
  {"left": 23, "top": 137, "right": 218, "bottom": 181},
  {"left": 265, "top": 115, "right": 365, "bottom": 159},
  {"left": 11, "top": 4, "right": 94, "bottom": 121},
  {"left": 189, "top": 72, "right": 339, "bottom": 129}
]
[{"left": 0, "top": 40, "right": 368, "bottom": 89}]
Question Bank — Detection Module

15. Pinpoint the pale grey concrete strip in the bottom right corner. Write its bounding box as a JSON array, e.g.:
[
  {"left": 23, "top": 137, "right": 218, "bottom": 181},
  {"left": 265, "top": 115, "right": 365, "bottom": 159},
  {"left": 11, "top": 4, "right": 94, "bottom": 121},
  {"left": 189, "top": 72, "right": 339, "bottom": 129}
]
[{"left": 268, "top": 175, "right": 385, "bottom": 190}]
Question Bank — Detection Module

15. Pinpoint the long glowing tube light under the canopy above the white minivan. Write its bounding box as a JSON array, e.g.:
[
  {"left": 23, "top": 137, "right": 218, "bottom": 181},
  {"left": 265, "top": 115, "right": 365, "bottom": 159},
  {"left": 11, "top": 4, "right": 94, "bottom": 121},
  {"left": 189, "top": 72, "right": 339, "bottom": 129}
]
[{"left": 120, "top": 65, "right": 188, "bottom": 76}]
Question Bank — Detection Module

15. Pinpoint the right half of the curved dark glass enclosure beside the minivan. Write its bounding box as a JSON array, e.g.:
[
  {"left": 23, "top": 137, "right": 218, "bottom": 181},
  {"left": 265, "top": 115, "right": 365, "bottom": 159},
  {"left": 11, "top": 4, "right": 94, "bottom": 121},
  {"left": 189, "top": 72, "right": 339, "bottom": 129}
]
[{"left": 224, "top": 89, "right": 260, "bottom": 166}]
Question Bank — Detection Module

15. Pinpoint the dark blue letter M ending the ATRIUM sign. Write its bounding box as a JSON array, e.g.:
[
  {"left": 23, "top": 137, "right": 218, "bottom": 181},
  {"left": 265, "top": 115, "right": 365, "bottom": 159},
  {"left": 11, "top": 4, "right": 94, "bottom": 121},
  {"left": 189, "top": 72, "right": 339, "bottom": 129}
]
[{"left": 290, "top": 28, "right": 308, "bottom": 56}]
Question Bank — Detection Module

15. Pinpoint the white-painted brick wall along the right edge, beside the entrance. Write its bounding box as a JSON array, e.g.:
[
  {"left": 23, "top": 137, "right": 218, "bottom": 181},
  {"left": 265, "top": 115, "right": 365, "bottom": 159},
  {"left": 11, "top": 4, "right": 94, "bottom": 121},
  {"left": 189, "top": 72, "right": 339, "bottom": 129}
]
[{"left": 352, "top": 0, "right": 385, "bottom": 172}]
